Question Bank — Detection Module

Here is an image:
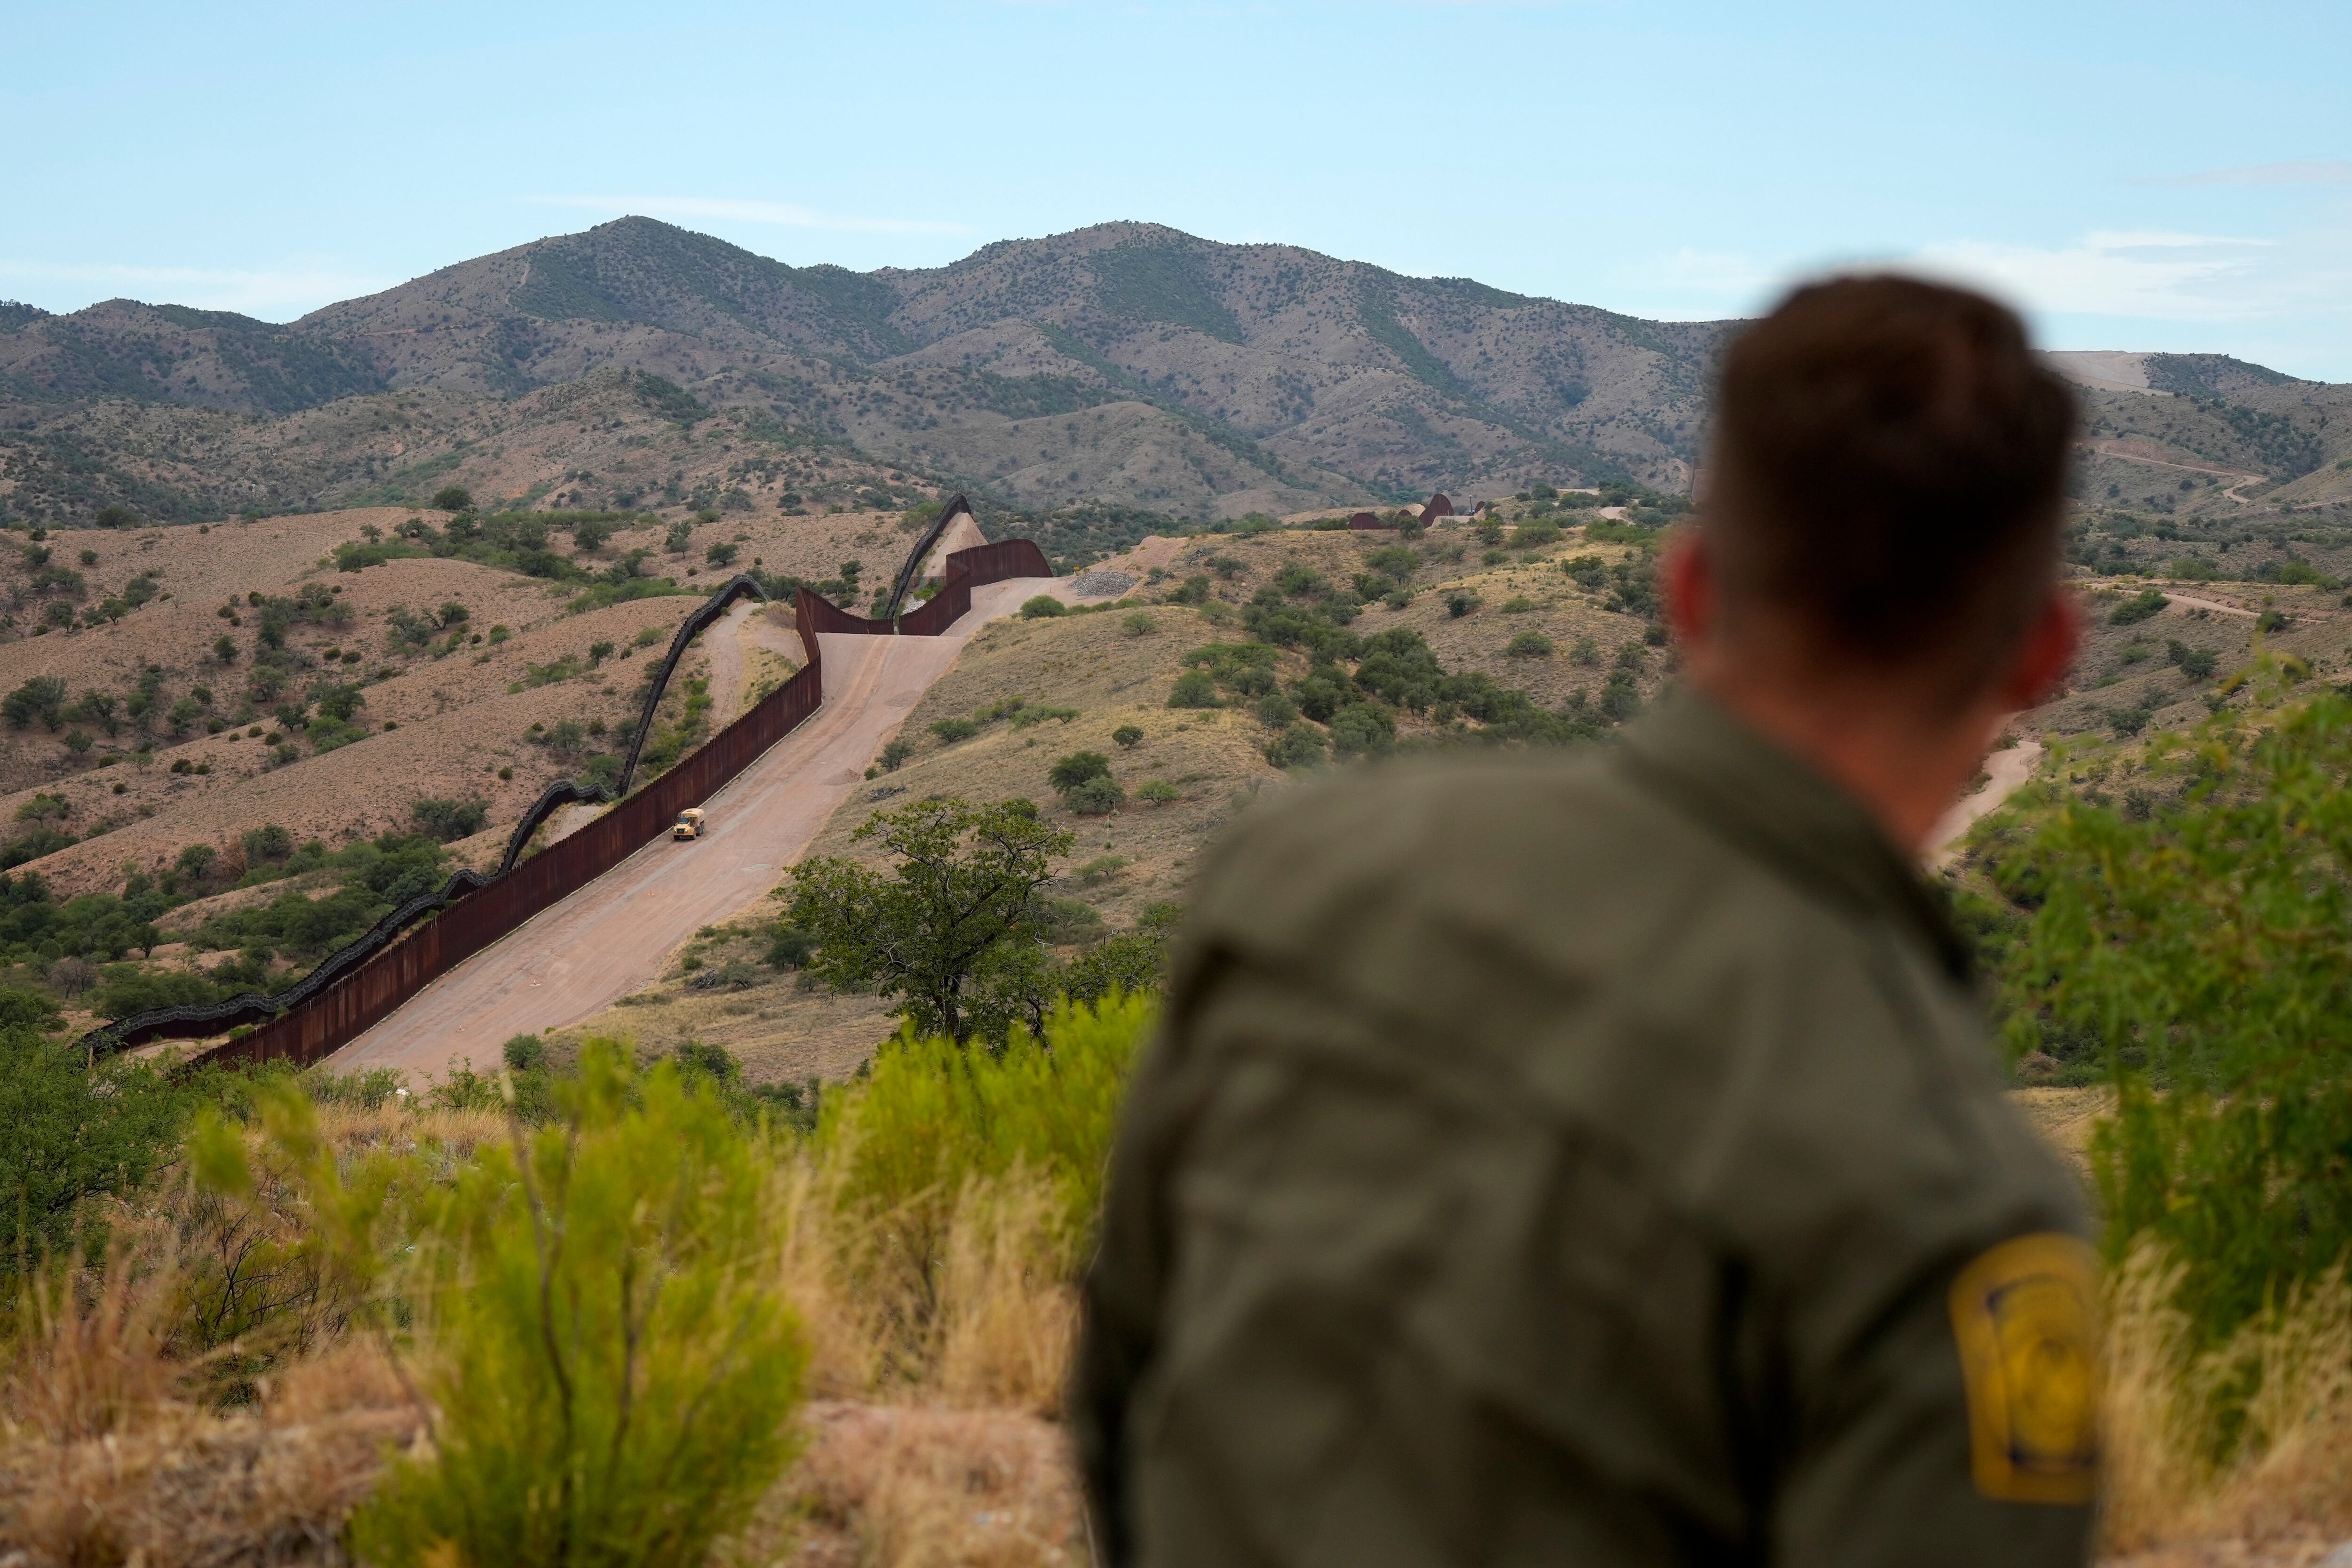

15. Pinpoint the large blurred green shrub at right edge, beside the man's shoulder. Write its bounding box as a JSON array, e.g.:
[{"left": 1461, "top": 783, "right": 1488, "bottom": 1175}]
[{"left": 2004, "top": 693, "right": 2352, "bottom": 1345}]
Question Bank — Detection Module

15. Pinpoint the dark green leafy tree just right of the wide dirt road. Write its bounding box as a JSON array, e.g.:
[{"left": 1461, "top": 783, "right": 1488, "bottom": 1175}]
[{"left": 786, "top": 799, "right": 1077, "bottom": 1042}]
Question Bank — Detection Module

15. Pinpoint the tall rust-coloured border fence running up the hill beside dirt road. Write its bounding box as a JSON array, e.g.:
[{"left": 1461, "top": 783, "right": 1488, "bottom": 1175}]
[{"left": 92, "top": 538, "right": 1054, "bottom": 1081}]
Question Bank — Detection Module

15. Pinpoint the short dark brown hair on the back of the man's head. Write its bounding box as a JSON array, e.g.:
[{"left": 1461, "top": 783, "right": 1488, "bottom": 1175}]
[{"left": 1703, "top": 278, "right": 2074, "bottom": 691}]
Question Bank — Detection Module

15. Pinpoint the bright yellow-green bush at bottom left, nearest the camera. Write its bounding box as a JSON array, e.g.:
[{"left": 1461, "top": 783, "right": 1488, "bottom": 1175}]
[{"left": 209, "top": 1042, "right": 807, "bottom": 1568}]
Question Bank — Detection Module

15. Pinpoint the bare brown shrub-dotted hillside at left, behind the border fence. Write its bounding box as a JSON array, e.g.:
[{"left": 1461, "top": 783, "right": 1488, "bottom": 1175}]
[{"left": 0, "top": 508, "right": 908, "bottom": 896}]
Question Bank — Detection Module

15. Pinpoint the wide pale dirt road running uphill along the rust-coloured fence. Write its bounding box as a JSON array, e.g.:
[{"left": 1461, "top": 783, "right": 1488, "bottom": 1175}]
[{"left": 329, "top": 578, "right": 1075, "bottom": 1075}]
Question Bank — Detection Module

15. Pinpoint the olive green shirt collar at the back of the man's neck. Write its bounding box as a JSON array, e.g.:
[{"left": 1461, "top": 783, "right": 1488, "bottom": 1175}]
[{"left": 1621, "top": 689, "right": 1971, "bottom": 983}]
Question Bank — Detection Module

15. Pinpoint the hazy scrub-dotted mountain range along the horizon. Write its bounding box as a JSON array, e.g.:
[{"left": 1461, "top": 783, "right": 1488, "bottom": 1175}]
[{"left": 0, "top": 216, "right": 2340, "bottom": 522}]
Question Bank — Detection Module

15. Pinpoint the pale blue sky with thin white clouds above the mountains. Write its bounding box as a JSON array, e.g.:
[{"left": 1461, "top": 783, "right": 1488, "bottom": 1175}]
[{"left": 14, "top": 0, "right": 2352, "bottom": 381}]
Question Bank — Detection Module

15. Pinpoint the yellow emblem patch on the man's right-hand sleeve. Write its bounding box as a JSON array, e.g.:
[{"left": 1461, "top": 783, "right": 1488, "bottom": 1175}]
[{"left": 1952, "top": 1234, "right": 2098, "bottom": 1502}]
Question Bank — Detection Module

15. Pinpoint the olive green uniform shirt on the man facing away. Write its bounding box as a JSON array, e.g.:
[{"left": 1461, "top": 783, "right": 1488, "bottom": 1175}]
[{"left": 1075, "top": 698, "right": 2096, "bottom": 1568}]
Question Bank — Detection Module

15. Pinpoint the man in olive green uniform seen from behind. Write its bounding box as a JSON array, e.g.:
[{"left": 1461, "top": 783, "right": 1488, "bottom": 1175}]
[{"left": 1073, "top": 278, "right": 2098, "bottom": 1568}]
